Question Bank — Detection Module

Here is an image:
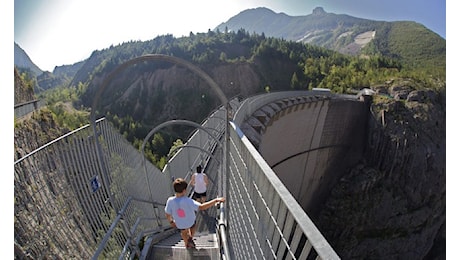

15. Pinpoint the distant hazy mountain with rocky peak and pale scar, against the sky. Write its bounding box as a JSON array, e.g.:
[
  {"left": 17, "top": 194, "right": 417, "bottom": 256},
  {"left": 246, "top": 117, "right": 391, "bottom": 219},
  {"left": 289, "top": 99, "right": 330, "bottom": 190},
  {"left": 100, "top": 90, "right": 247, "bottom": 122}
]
[{"left": 215, "top": 7, "right": 446, "bottom": 67}]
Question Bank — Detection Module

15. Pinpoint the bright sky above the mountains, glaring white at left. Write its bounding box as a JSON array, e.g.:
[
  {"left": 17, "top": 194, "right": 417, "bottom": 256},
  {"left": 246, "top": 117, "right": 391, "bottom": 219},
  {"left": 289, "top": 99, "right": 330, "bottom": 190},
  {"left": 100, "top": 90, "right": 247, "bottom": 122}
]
[{"left": 13, "top": 0, "right": 446, "bottom": 71}]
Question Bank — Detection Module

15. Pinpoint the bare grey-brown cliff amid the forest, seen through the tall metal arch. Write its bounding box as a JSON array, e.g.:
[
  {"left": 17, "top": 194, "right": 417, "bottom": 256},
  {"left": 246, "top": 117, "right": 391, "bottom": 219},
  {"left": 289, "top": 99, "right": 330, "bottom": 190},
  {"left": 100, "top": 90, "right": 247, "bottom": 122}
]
[{"left": 82, "top": 63, "right": 261, "bottom": 125}]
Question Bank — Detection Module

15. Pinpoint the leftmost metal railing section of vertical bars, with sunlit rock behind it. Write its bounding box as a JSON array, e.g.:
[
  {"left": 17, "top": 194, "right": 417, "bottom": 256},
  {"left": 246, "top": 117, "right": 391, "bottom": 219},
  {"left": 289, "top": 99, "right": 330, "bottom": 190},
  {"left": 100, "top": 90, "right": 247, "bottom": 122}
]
[{"left": 14, "top": 119, "right": 111, "bottom": 258}]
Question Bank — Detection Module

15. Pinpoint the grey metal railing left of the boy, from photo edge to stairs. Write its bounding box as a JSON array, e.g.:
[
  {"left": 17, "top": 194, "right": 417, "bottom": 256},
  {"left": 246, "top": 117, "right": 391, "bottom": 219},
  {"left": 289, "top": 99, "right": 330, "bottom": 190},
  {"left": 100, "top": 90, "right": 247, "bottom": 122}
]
[{"left": 14, "top": 119, "right": 171, "bottom": 259}]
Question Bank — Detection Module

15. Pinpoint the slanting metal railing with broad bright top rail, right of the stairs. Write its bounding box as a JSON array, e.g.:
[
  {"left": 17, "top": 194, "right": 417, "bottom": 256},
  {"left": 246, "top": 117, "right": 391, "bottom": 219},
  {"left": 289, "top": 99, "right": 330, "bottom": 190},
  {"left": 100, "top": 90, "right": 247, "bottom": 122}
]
[{"left": 227, "top": 123, "right": 340, "bottom": 259}]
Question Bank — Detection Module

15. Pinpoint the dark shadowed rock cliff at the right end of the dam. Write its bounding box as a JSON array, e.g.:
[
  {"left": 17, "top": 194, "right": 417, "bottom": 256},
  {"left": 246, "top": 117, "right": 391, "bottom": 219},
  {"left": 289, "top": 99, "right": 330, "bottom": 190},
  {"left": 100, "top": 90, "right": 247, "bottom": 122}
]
[{"left": 318, "top": 83, "right": 446, "bottom": 259}]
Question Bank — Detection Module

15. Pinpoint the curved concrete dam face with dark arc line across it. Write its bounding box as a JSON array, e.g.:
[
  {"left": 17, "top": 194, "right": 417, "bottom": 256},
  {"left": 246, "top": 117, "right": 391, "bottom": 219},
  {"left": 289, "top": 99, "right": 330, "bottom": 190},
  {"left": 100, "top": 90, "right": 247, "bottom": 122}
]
[{"left": 241, "top": 95, "right": 369, "bottom": 218}]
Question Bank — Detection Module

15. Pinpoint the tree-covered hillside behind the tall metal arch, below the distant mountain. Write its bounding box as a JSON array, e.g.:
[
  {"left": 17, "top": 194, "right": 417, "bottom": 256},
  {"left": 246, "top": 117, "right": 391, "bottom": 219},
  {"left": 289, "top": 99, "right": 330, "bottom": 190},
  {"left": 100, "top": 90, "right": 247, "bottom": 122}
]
[{"left": 55, "top": 29, "right": 445, "bottom": 168}]
